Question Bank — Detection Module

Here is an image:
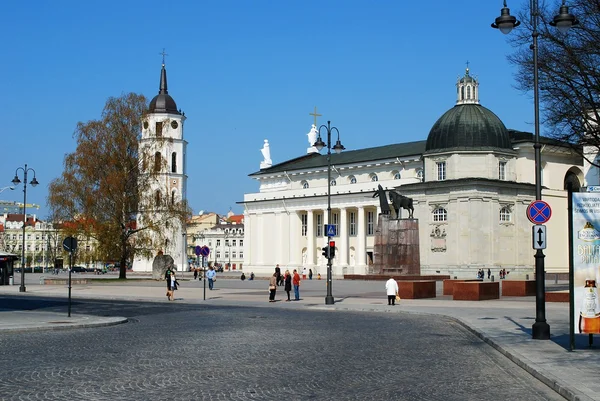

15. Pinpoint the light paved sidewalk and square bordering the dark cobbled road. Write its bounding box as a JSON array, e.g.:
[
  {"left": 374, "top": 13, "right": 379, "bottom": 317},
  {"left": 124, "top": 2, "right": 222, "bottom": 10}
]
[{"left": 0, "top": 279, "right": 600, "bottom": 401}]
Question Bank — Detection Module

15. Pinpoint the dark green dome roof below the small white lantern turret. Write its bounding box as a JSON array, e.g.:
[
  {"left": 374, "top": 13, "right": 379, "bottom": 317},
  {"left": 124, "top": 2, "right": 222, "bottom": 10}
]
[{"left": 425, "top": 104, "right": 512, "bottom": 152}]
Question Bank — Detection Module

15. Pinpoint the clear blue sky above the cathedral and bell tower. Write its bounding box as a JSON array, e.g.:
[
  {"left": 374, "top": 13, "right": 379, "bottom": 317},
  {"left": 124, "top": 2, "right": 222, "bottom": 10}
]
[{"left": 0, "top": 0, "right": 533, "bottom": 217}]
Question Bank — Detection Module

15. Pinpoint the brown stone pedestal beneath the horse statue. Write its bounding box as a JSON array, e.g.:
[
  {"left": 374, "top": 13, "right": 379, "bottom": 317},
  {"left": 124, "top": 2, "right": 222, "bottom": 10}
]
[{"left": 372, "top": 214, "right": 421, "bottom": 275}]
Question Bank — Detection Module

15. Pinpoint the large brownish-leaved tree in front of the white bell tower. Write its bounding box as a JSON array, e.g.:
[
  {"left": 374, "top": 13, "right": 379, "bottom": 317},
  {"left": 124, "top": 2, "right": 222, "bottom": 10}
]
[{"left": 48, "top": 93, "right": 191, "bottom": 278}]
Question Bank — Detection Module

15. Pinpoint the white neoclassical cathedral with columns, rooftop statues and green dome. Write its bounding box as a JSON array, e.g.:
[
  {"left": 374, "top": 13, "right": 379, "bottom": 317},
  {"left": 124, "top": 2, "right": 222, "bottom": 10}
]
[{"left": 240, "top": 68, "right": 598, "bottom": 278}]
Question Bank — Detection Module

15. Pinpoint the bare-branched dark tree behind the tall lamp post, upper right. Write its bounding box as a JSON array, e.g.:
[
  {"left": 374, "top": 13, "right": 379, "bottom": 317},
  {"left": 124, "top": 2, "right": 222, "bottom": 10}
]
[{"left": 508, "top": 0, "right": 600, "bottom": 163}]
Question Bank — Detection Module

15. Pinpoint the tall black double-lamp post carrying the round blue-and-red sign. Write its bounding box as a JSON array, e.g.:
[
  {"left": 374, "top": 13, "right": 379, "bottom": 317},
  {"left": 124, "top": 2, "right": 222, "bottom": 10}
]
[{"left": 492, "top": 0, "right": 579, "bottom": 340}]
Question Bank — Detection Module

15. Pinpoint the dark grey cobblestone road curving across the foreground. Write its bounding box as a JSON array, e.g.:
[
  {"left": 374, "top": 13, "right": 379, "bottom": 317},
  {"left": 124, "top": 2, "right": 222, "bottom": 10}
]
[{"left": 0, "top": 300, "right": 562, "bottom": 401}]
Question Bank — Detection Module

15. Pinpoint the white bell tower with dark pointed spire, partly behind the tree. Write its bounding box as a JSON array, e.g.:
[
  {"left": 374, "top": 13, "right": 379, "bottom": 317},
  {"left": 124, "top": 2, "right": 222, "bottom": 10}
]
[{"left": 133, "top": 60, "right": 187, "bottom": 271}]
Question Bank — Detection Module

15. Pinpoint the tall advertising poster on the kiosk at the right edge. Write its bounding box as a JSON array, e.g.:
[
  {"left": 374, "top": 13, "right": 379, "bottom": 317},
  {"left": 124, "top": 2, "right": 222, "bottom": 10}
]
[{"left": 572, "top": 192, "right": 600, "bottom": 334}]
